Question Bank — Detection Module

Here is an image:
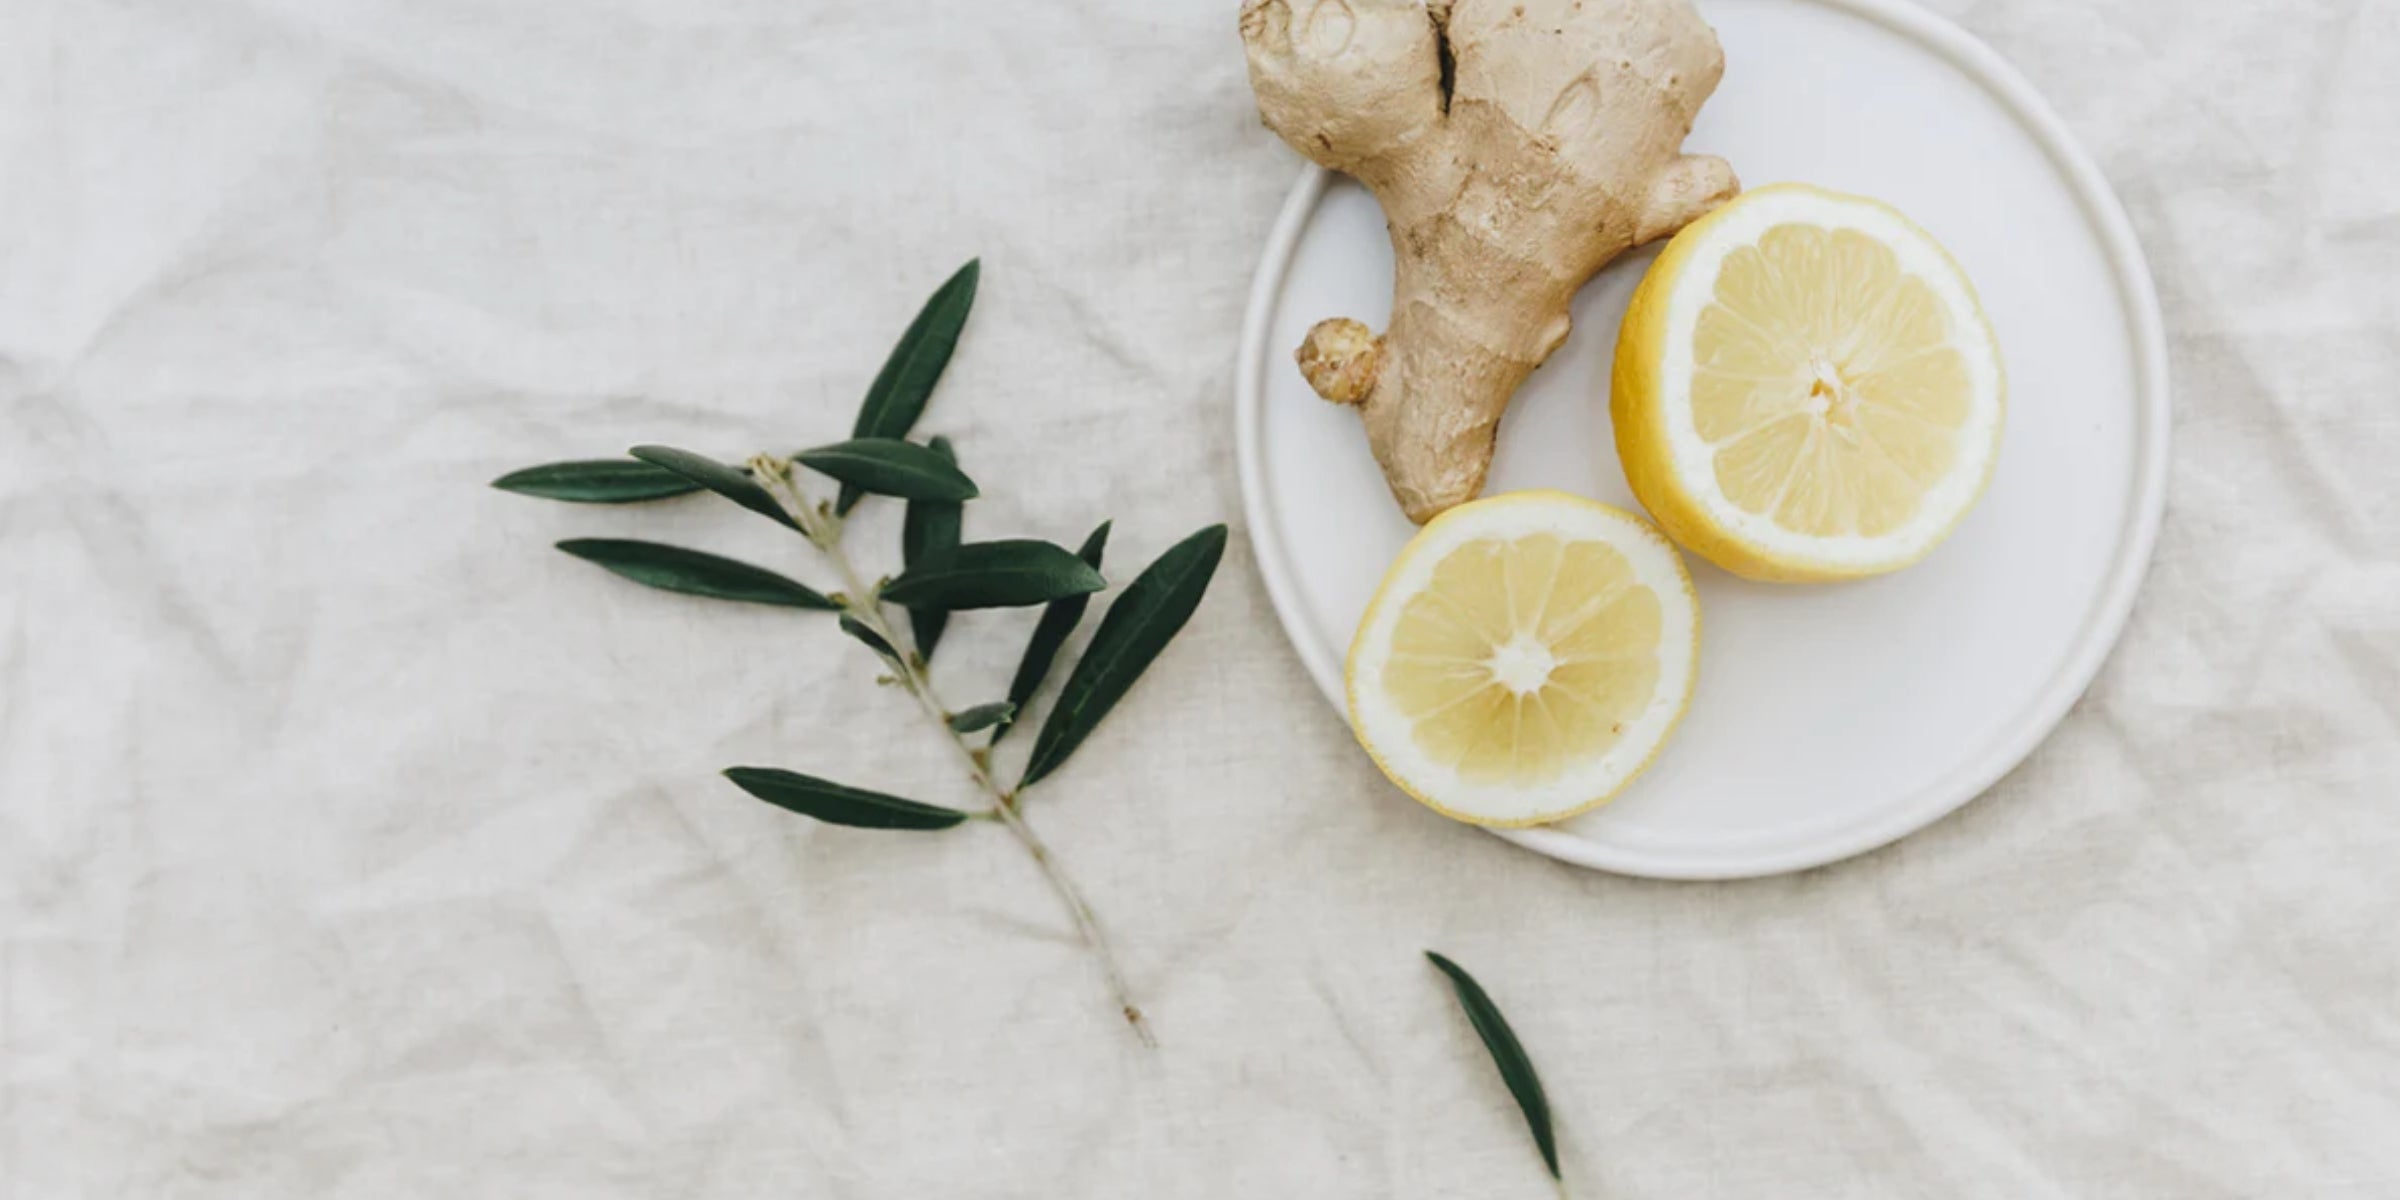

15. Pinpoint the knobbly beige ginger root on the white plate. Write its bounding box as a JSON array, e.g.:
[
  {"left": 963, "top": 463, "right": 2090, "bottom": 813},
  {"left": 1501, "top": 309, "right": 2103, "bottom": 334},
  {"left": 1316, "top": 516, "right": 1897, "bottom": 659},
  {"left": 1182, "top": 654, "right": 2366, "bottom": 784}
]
[{"left": 1241, "top": 0, "right": 1740, "bottom": 523}]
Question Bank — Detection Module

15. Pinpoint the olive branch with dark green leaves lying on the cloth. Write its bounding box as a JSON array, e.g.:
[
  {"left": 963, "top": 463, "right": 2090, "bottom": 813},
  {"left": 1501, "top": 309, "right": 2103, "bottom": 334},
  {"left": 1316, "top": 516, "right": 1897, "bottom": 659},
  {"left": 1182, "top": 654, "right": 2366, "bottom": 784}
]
[{"left": 492, "top": 262, "right": 1226, "bottom": 1044}]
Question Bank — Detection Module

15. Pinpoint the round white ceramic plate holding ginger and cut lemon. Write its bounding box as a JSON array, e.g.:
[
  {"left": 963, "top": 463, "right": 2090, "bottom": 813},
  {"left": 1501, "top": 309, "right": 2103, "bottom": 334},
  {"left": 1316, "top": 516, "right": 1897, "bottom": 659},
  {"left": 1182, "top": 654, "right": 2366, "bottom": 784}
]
[{"left": 1236, "top": 0, "right": 2167, "bottom": 878}]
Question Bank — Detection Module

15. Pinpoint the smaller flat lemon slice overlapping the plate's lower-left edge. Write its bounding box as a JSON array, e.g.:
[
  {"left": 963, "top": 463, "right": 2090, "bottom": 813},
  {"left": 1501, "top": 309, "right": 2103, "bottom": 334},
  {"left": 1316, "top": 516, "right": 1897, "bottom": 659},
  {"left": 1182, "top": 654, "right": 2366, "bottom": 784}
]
[{"left": 1346, "top": 492, "right": 1699, "bottom": 826}]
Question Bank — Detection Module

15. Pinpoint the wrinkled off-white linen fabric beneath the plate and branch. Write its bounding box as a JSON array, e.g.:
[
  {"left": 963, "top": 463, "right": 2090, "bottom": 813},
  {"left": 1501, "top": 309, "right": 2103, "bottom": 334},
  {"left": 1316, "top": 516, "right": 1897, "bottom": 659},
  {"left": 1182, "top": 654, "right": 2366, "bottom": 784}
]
[{"left": 0, "top": 0, "right": 2400, "bottom": 1200}]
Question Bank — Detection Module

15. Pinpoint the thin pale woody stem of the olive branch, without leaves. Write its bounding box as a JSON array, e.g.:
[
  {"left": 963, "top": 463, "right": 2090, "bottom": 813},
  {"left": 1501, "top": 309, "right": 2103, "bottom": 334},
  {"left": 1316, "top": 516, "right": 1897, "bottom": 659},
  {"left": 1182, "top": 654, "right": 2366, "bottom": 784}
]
[{"left": 749, "top": 454, "right": 1159, "bottom": 1046}]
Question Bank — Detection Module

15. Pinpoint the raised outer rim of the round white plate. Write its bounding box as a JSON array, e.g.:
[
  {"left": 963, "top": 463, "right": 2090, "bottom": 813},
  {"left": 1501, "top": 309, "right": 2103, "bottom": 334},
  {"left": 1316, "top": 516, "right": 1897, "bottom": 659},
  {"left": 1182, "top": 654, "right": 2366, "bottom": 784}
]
[{"left": 1234, "top": 0, "right": 2172, "bottom": 881}]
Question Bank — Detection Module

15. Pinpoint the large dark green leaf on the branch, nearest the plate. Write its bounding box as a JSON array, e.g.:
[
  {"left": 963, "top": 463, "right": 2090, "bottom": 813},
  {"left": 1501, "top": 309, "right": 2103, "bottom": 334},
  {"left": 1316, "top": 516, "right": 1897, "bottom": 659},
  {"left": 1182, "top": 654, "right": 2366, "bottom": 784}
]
[{"left": 1018, "top": 526, "right": 1224, "bottom": 787}]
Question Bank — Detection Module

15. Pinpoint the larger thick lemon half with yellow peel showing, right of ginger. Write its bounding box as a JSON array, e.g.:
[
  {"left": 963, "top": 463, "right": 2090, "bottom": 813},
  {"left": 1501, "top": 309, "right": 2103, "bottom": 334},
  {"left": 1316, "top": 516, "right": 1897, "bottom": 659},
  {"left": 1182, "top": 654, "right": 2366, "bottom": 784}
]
[{"left": 1610, "top": 185, "right": 2004, "bottom": 581}]
